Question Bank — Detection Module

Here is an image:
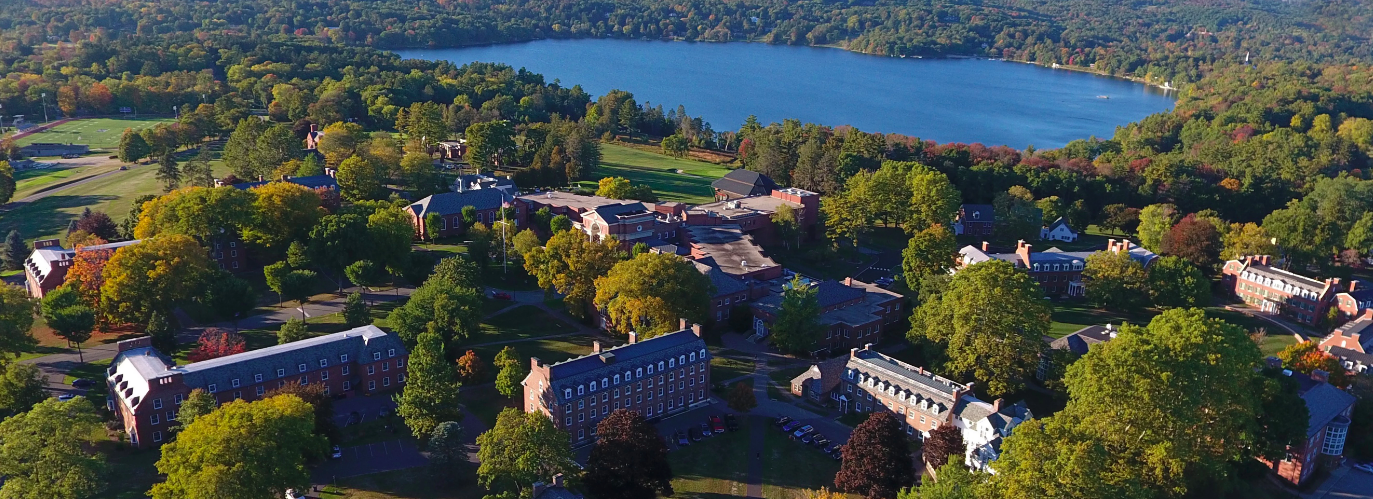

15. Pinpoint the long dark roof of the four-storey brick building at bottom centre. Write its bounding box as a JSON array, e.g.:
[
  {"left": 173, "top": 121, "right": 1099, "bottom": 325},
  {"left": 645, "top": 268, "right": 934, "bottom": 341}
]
[{"left": 548, "top": 329, "right": 710, "bottom": 404}]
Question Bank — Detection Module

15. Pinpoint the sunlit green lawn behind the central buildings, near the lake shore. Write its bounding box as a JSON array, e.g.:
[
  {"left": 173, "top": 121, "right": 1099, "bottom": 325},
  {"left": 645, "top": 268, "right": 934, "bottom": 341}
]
[{"left": 577, "top": 144, "right": 729, "bottom": 203}]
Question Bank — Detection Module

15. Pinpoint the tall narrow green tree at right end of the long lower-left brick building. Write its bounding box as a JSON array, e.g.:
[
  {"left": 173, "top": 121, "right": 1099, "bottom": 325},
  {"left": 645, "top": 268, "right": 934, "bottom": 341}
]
[{"left": 395, "top": 331, "right": 463, "bottom": 439}]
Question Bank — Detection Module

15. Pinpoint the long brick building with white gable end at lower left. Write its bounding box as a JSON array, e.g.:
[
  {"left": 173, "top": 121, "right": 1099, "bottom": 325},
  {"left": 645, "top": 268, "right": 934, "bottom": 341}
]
[{"left": 106, "top": 326, "right": 409, "bottom": 448}]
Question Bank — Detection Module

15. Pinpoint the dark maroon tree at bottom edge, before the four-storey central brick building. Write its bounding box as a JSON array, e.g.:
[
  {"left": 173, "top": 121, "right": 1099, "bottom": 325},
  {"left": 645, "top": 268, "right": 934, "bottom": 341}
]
[{"left": 585, "top": 408, "right": 673, "bottom": 499}]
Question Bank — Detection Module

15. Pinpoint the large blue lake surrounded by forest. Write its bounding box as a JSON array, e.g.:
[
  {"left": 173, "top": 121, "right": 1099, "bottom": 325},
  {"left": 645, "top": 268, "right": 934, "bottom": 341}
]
[{"left": 397, "top": 40, "right": 1174, "bottom": 148}]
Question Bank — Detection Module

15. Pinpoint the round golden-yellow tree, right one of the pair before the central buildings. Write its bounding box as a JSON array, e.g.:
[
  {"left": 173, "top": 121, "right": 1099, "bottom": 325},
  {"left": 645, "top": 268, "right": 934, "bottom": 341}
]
[{"left": 595, "top": 253, "right": 715, "bottom": 340}]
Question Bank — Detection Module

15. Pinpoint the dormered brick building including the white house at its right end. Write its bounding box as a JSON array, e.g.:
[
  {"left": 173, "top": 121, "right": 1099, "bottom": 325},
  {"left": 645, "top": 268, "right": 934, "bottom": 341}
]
[{"left": 791, "top": 345, "right": 1034, "bottom": 470}]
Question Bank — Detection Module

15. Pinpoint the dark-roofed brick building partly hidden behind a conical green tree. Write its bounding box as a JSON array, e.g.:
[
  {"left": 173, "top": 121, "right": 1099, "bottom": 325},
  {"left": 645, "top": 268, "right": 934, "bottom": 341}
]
[{"left": 750, "top": 278, "right": 905, "bottom": 355}]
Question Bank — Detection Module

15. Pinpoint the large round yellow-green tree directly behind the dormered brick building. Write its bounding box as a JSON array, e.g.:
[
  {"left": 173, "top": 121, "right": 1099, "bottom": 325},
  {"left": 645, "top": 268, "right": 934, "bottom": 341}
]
[{"left": 908, "top": 260, "right": 1050, "bottom": 396}]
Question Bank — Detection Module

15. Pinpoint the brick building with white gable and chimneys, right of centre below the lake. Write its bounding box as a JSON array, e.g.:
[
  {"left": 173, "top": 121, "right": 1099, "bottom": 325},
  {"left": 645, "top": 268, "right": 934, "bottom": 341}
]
[{"left": 958, "top": 239, "right": 1159, "bottom": 297}]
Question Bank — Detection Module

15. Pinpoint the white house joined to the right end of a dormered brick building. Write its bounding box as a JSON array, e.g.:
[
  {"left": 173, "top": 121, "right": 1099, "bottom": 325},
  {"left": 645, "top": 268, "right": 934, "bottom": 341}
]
[{"left": 954, "top": 395, "right": 1034, "bottom": 473}]
